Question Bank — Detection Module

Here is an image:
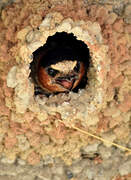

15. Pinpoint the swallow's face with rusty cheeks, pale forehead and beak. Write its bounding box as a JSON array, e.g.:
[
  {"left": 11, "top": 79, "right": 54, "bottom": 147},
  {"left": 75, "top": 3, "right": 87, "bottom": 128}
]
[{"left": 38, "top": 60, "right": 85, "bottom": 93}]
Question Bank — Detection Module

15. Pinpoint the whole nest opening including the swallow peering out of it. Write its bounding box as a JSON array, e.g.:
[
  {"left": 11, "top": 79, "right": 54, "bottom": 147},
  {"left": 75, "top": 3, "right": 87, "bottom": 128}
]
[{"left": 30, "top": 32, "right": 90, "bottom": 96}]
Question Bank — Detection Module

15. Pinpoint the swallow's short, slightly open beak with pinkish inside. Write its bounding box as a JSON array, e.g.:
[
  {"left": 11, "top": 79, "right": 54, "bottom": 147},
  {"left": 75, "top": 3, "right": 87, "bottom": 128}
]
[{"left": 56, "top": 76, "right": 76, "bottom": 90}]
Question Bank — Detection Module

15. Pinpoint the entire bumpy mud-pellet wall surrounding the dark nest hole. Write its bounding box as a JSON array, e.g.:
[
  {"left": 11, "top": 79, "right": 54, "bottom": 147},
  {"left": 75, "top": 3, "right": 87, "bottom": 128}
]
[{"left": 0, "top": 0, "right": 131, "bottom": 180}]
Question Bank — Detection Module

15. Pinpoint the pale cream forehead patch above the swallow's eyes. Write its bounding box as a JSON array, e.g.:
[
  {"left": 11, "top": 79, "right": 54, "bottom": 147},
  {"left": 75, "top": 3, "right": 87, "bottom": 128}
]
[{"left": 51, "top": 60, "right": 77, "bottom": 72}]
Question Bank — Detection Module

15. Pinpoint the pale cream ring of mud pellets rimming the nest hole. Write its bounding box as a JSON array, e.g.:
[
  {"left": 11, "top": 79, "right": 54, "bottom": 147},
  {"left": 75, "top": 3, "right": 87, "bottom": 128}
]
[{"left": 7, "top": 12, "right": 110, "bottom": 127}]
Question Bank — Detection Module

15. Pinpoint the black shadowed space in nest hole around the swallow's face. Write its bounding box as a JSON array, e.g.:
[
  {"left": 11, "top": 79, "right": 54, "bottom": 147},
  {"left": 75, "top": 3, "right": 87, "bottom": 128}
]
[{"left": 30, "top": 32, "right": 90, "bottom": 96}]
